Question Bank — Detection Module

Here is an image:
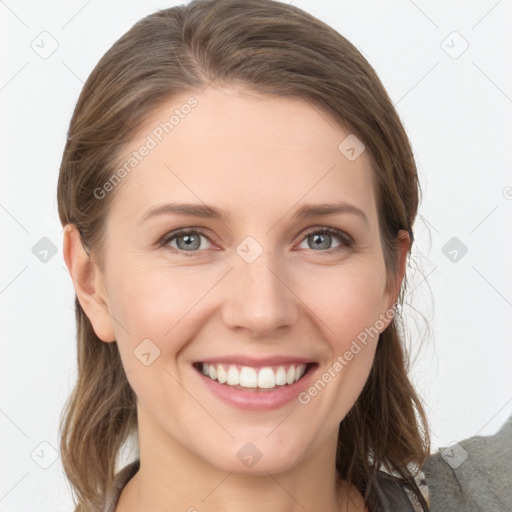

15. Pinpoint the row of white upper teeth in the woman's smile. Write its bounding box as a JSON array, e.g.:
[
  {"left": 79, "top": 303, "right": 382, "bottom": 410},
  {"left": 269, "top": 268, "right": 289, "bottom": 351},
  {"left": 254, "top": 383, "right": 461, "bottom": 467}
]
[{"left": 201, "top": 363, "right": 306, "bottom": 389}]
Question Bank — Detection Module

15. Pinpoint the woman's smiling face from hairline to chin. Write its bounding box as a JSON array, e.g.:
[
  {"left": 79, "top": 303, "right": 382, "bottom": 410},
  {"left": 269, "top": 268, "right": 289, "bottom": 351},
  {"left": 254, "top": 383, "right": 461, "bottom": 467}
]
[{"left": 71, "top": 86, "right": 406, "bottom": 472}]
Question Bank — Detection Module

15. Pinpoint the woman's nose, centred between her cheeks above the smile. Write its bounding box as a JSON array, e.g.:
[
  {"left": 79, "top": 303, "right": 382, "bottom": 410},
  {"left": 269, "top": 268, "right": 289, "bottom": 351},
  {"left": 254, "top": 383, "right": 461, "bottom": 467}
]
[{"left": 222, "top": 246, "right": 300, "bottom": 338}]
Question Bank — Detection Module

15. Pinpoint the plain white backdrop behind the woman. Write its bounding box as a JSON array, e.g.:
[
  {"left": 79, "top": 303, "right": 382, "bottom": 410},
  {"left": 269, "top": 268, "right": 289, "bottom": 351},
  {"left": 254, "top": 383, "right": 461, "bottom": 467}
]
[{"left": 0, "top": 0, "right": 512, "bottom": 512}]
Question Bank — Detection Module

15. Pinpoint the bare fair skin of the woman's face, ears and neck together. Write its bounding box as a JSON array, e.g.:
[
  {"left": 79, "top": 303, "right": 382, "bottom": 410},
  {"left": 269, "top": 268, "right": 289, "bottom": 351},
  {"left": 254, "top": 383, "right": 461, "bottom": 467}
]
[{"left": 64, "top": 86, "right": 410, "bottom": 512}]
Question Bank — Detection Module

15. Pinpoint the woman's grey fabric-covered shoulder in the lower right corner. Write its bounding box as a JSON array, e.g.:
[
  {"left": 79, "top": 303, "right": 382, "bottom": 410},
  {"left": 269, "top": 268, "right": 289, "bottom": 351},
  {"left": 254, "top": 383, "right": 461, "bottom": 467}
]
[{"left": 423, "top": 416, "right": 512, "bottom": 512}]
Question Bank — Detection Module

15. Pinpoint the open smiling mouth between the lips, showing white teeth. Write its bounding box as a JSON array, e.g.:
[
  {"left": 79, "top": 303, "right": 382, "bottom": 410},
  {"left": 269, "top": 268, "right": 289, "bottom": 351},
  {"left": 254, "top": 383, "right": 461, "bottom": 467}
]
[{"left": 193, "top": 362, "right": 317, "bottom": 392}]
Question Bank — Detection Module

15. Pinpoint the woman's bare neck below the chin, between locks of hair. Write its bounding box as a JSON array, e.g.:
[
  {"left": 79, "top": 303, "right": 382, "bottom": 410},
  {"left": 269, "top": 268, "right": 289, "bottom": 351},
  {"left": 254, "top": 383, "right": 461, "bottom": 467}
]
[{"left": 116, "top": 414, "right": 365, "bottom": 512}]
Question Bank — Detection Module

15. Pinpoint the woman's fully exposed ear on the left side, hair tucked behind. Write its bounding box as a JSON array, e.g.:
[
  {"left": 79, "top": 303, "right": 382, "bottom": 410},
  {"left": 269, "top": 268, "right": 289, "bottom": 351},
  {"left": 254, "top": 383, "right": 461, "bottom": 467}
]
[{"left": 63, "top": 224, "right": 116, "bottom": 342}]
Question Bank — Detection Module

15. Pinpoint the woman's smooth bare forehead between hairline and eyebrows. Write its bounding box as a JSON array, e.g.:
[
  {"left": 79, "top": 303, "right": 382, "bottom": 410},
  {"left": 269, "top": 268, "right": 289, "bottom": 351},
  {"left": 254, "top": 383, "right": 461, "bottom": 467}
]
[{"left": 113, "top": 86, "right": 376, "bottom": 227}]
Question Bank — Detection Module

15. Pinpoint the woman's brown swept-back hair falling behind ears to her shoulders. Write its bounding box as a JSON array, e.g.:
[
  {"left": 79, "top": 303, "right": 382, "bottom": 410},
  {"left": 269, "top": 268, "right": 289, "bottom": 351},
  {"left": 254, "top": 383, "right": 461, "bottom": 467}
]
[{"left": 57, "top": 0, "right": 430, "bottom": 512}]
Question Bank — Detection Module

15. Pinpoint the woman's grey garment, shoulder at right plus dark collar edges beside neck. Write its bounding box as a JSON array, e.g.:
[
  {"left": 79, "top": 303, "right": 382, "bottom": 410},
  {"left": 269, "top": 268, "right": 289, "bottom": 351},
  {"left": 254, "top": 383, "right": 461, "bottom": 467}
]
[{"left": 102, "top": 416, "right": 512, "bottom": 512}]
